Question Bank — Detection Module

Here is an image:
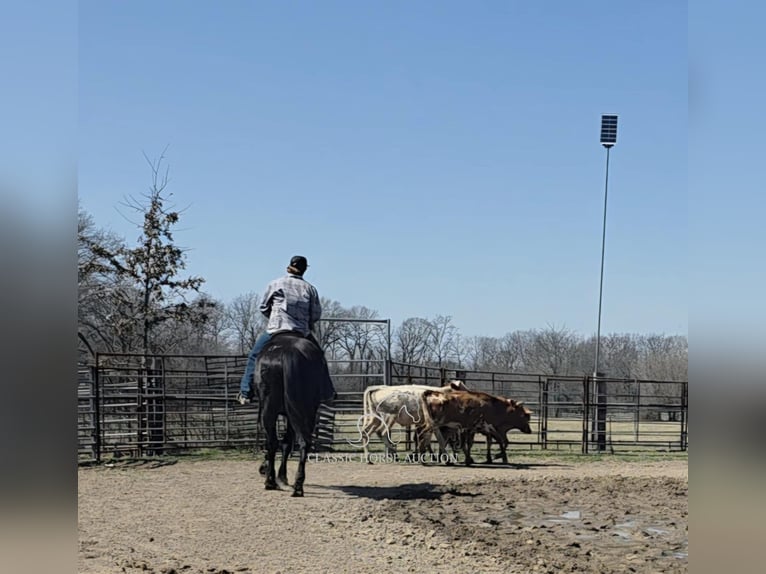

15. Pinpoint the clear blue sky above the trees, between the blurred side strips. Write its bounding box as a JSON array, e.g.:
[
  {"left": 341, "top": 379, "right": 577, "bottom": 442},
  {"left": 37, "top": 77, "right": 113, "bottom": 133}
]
[{"left": 78, "top": 1, "right": 689, "bottom": 336}]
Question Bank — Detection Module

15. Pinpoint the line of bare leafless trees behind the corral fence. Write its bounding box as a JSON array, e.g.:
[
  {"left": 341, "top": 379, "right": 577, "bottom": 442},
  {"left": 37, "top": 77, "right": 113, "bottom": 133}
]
[{"left": 77, "top": 157, "right": 688, "bottom": 381}]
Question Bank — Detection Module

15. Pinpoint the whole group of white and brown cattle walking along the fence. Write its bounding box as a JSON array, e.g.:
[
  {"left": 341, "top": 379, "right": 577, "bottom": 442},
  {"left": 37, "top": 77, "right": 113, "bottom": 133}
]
[{"left": 361, "top": 380, "right": 532, "bottom": 465}]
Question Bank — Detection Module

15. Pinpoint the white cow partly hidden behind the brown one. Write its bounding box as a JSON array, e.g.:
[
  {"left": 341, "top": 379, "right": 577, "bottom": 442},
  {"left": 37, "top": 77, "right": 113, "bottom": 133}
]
[{"left": 360, "top": 380, "right": 466, "bottom": 463}]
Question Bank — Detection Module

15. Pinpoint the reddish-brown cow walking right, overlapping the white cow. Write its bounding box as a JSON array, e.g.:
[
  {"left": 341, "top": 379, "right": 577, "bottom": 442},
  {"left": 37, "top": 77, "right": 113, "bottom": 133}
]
[{"left": 421, "top": 390, "right": 532, "bottom": 465}]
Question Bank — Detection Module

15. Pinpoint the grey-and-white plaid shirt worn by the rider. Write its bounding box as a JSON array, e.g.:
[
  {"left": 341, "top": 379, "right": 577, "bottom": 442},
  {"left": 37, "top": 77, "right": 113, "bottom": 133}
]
[{"left": 261, "top": 273, "right": 322, "bottom": 337}]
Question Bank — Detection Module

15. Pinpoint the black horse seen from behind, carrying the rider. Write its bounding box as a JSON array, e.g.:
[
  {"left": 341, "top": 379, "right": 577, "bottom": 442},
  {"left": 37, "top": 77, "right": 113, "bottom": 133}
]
[{"left": 255, "top": 333, "right": 335, "bottom": 496}]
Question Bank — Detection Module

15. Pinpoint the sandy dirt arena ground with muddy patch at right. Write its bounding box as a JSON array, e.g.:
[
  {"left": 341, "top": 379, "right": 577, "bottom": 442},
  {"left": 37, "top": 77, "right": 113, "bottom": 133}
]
[{"left": 79, "top": 455, "right": 688, "bottom": 574}]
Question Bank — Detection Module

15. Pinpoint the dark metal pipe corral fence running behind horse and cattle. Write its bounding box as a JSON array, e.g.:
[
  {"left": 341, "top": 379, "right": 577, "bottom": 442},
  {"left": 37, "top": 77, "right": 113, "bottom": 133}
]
[{"left": 77, "top": 353, "right": 689, "bottom": 461}]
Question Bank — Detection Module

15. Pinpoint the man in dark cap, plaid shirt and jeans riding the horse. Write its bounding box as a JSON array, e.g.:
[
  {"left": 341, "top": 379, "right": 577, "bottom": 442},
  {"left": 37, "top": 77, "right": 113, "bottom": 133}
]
[{"left": 237, "top": 255, "right": 322, "bottom": 405}]
